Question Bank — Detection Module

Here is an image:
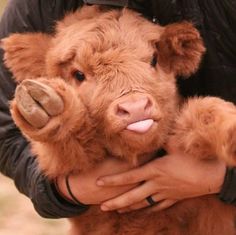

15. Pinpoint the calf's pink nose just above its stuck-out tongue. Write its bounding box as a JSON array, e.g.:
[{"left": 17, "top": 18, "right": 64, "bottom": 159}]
[{"left": 116, "top": 96, "right": 153, "bottom": 123}]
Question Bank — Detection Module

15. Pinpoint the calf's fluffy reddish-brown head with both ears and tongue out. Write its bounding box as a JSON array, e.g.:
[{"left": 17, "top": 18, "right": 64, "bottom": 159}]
[{"left": 3, "top": 7, "right": 204, "bottom": 162}]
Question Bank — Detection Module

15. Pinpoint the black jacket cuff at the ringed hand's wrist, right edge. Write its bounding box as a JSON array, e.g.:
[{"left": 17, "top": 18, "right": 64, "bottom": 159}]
[{"left": 219, "top": 167, "right": 236, "bottom": 205}]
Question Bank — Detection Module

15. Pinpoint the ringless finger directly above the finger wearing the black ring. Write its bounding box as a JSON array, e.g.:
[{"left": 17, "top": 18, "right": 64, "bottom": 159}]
[{"left": 101, "top": 181, "right": 154, "bottom": 211}]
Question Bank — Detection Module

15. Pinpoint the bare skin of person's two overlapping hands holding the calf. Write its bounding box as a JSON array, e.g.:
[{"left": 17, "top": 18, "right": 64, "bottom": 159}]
[{"left": 58, "top": 153, "right": 226, "bottom": 213}]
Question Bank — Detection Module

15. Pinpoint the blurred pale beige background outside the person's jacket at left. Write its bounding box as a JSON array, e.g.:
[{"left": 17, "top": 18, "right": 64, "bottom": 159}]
[{"left": 0, "top": 0, "right": 69, "bottom": 235}]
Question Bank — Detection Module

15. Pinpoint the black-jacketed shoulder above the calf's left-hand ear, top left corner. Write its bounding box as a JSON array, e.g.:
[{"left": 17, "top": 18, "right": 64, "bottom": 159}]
[{"left": 0, "top": 0, "right": 83, "bottom": 38}]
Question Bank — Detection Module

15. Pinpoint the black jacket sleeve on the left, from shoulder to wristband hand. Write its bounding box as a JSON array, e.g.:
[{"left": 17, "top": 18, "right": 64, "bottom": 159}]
[{"left": 0, "top": 0, "right": 87, "bottom": 218}]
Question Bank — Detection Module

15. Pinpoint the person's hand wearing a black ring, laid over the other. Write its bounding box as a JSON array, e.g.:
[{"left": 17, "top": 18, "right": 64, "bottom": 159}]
[{"left": 97, "top": 154, "right": 226, "bottom": 213}]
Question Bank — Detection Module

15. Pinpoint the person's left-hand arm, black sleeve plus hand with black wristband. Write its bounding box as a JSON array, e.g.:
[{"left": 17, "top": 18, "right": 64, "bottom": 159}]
[{"left": 0, "top": 0, "right": 141, "bottom": 218}]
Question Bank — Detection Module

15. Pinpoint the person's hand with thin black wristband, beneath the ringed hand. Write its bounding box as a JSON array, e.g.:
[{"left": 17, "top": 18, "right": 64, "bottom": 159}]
[{"left": 57, "top": 159, "right": 136, "bottom": 205}]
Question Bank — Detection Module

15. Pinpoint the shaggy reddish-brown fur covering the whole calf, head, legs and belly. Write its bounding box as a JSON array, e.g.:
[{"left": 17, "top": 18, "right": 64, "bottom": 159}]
[{"left": 3, "top": 7, "right": 236, "bottom": 235}]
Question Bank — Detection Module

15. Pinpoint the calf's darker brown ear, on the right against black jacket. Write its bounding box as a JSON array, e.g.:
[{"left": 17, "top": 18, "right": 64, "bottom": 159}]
[{"left": 156, "top": 22, "right": 205, "bottom": 77}]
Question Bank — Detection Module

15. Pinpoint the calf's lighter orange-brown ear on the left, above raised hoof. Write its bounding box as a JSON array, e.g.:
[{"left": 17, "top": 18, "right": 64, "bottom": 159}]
[{"left": 0, "top": 33, "right": 51, "bottom": 82}]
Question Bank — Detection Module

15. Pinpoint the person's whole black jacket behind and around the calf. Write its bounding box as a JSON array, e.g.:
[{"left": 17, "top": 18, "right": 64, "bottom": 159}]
[{"left": 0, "top": 0, "right": 236, "bottom": 218}]
